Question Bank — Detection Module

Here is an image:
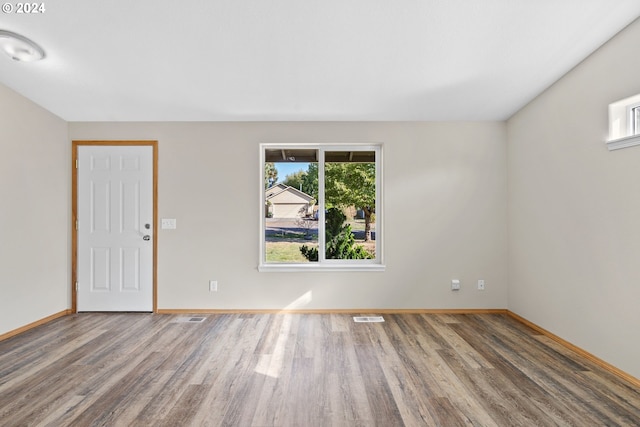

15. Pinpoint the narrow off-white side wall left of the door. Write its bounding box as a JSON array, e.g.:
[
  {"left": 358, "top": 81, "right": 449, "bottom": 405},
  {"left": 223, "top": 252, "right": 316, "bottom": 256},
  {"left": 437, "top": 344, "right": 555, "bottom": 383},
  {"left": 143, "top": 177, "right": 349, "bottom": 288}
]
[{"left": 0, "top": 85, "right": 71, "bottom": 334}]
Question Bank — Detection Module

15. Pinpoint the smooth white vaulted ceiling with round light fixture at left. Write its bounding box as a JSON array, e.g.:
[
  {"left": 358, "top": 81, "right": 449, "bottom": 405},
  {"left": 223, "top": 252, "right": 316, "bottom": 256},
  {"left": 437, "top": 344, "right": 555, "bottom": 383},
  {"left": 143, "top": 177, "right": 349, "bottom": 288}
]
[{"left": 0, "top": 0, "right": 640, "bottom": 121}]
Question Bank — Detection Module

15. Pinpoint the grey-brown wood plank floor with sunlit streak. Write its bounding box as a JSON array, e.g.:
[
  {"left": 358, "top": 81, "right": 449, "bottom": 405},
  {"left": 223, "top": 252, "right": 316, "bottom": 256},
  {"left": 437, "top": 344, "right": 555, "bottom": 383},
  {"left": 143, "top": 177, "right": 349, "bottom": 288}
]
[{"left": 0, "top": 313, "right": 640, "bottom": 427}]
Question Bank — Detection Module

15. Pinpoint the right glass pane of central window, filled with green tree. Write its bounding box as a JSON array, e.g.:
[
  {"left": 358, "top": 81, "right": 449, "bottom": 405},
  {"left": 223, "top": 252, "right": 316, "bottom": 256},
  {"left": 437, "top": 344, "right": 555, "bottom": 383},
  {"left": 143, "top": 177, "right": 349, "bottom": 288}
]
[{"left": 324, "top": 151, "right": 376, "bottom": 259}]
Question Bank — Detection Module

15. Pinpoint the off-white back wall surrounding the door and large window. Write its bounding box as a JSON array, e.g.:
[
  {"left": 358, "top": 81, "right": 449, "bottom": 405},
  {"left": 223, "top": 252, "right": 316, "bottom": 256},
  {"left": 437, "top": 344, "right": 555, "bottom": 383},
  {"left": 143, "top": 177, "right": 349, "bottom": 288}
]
[{"left": 69, "top": 123, "right": 507, "bottom": 309}]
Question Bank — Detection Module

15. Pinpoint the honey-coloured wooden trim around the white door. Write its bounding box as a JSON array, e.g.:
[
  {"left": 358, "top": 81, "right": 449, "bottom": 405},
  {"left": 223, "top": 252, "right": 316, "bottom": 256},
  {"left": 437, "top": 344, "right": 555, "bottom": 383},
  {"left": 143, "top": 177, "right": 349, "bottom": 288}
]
[{"left": 71, "top": 141, "right": 158, "bottom": 313}]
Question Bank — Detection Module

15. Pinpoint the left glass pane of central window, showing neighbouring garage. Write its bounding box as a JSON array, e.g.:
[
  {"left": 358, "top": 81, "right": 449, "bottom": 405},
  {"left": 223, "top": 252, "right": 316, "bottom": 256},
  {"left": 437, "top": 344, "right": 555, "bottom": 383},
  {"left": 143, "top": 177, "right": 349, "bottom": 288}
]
[{"left": 264, "top": 149, "right": 318, "bottom": 263}]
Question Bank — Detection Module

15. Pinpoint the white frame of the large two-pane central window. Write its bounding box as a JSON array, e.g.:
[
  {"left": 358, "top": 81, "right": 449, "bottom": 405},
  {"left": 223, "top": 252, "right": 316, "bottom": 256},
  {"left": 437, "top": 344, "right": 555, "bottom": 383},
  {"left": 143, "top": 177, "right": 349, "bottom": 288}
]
[{"left": 258, "top": 143, "right": 385, "bottom": 272}]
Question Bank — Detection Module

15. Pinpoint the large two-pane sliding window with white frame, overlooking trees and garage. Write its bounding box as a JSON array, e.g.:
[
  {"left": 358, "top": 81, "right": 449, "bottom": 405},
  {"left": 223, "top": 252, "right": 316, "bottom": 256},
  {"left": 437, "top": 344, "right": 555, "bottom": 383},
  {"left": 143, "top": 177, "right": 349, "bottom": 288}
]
[{"left": 259, "top": 144, "right": 384, "bottom": 271}]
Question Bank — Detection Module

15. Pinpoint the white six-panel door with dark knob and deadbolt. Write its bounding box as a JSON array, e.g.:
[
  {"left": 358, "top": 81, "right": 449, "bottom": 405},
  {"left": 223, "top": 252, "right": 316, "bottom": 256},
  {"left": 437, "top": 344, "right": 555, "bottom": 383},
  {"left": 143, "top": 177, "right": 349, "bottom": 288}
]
[{"left": 77, "top": 145, "right": 155, "bottom": 312}]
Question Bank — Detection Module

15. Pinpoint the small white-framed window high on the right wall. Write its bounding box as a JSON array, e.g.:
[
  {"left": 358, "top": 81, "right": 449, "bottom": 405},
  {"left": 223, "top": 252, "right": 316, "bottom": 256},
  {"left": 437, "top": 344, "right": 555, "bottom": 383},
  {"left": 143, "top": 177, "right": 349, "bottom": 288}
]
[{"left": 607, "top": 94, "right": 640, "bottom": 151}]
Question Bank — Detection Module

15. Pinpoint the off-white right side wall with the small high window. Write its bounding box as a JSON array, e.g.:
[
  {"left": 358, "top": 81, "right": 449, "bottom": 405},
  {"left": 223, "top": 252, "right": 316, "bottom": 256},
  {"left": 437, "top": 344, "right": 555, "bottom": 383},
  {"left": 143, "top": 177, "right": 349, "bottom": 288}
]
[{"left": 508, "top": 21, "right": 640, "bottom": 378}]
